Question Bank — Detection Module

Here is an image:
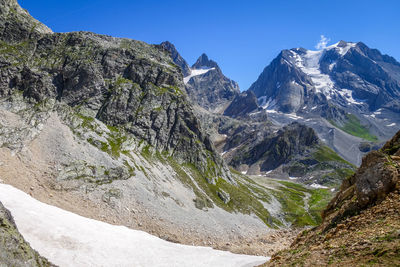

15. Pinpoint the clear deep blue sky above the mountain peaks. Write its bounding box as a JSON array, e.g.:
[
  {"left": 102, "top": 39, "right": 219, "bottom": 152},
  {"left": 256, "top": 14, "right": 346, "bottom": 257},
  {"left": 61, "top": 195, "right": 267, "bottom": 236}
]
[{"left": 19, "top": 0, "right": 400, "bottom": 90}]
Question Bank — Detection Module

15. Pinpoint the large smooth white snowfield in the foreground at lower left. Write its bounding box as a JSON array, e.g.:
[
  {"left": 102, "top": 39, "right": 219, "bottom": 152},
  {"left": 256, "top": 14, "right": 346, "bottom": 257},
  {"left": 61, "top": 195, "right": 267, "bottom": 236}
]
[{"left": 0, "top": 184, "right": 268, "bottom": 267}]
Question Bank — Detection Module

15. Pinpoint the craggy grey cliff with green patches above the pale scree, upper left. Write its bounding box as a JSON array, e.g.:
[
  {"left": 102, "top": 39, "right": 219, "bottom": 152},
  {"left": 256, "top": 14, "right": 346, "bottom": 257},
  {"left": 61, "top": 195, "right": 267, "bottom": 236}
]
[{"left": 0, "top": 1, "right": 230, "bottom": 181}]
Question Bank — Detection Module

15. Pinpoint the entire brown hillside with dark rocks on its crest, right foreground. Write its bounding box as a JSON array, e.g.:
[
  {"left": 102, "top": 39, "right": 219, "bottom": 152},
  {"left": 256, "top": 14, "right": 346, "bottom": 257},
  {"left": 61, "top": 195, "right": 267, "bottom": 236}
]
[{"left": 268, "top": 132, "right": 400, "bottom": 266}]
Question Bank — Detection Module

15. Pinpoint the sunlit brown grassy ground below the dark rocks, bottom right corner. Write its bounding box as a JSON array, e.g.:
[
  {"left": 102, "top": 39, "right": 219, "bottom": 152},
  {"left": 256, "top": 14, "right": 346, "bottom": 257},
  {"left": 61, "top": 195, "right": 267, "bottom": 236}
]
[{"left": 263, "top": 189, "right": 400, "bottom": 266}]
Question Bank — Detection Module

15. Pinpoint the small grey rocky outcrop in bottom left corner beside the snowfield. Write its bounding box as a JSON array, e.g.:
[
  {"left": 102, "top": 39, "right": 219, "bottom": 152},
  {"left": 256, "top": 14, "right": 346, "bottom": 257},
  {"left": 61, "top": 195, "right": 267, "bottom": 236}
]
[{"left": 0, "top": 202, "right": 54, "bottom": 267}]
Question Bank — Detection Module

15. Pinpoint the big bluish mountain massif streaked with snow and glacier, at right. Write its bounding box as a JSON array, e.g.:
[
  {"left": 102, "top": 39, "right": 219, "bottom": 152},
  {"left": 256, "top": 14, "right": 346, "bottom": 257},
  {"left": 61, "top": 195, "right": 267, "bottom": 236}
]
[{"left": 244, "top": 41, "right": 400, "bottom": 165}]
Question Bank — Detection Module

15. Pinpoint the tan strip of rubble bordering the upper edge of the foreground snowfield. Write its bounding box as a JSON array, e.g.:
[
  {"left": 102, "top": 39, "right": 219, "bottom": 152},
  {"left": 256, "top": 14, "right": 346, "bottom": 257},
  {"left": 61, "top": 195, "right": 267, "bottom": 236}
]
[{"left": 0, "top": 148, "right": 298, "bottom": 256}]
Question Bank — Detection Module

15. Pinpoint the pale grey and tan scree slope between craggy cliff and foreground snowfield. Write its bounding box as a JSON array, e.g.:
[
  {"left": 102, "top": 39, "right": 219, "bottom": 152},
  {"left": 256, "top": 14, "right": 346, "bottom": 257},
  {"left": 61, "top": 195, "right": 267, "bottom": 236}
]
[{"left": 0, "top": 110, "right": 297, "bottom": 256}]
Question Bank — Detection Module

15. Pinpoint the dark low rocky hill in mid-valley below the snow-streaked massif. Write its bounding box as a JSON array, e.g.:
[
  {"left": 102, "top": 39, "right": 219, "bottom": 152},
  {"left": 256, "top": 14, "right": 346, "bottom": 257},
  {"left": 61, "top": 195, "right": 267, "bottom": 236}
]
[{"left": 223, "top": 122, "right": 354, "bottom": 187}]
